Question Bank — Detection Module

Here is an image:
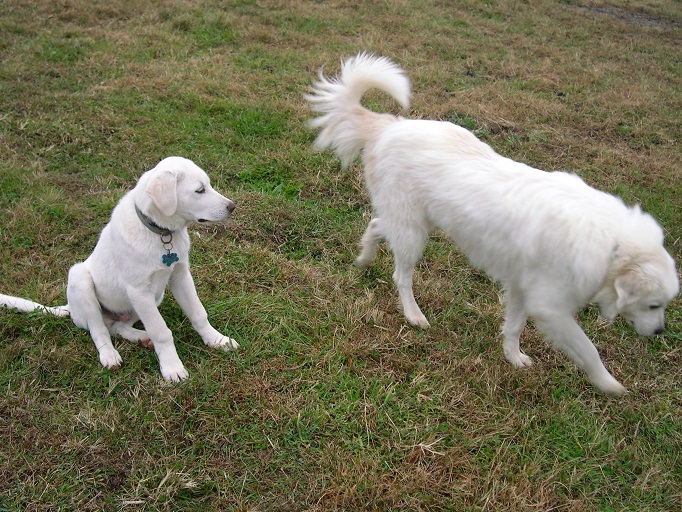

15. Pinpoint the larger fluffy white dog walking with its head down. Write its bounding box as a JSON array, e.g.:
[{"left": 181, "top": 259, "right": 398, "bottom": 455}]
[{"left": 306, "top": 53, "right": 679, "bottom": 396}]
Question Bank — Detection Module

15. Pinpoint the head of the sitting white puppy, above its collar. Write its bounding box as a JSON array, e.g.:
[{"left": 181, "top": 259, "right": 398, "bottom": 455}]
[{"left": 136, "top": 156, "right": 235, "bottom": 229}]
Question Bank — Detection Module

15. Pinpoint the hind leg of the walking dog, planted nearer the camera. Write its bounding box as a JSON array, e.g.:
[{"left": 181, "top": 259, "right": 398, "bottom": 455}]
[{"left": 386, "top": 226, "right": 429, "bottom": 329}]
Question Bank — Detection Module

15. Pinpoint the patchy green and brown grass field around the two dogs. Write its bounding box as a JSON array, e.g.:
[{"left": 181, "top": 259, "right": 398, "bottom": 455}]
[{"left": 0, "top": 0, "right": 682, "bottom": 512}]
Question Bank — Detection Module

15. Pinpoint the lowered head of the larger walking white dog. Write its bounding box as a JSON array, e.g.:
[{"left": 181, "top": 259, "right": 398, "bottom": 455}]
[{"left": 600, "top": 247, "right": 680, "bottom": 336}]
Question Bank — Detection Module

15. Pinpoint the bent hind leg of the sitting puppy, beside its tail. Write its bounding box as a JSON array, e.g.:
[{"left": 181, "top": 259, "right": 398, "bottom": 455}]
[{"left": 66, "top": 263, "right": 123, "bottom": 370}]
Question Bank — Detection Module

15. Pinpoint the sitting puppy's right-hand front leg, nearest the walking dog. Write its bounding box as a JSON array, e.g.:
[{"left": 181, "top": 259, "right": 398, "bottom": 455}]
[{"left": 170, "top": 265, "right": 239, "bottom": 350}]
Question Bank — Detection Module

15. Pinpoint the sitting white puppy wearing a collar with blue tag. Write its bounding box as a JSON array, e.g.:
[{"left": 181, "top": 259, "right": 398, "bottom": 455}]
[{"left": 0, "top": 157, "right": 239, "bottom": 382}]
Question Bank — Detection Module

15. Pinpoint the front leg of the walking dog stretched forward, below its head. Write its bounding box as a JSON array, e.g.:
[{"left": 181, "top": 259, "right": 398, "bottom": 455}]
[{"left": 533, "top": 312, "right": 627, "bottom": 397}]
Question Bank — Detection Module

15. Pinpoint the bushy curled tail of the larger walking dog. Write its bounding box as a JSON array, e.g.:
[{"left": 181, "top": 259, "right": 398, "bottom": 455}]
[{"left": 304, "top": 52, "right": 410, "bottom": 168}]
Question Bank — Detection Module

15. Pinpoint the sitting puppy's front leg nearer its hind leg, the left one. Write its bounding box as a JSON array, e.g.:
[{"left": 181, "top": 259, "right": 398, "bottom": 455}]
[{"left": 128, "top": 288, "right": 189, "bottom": 382}]
